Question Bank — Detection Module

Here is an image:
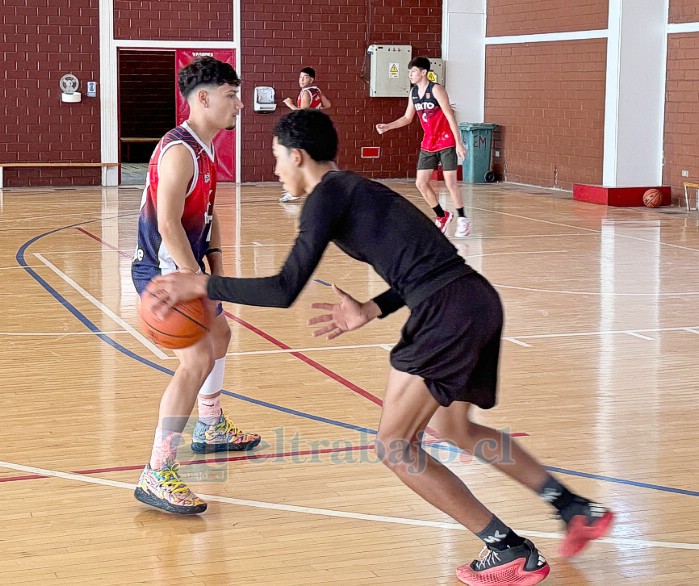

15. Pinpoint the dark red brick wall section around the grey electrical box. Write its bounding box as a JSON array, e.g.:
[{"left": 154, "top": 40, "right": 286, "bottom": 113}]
[{"left": 241, "top": 0, "right": 442, "bottom": 181}]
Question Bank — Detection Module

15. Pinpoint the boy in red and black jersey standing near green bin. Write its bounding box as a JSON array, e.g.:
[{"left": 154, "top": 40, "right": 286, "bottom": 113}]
[{"left": 376, "top": 57, "right": 471, "bottom": 238}]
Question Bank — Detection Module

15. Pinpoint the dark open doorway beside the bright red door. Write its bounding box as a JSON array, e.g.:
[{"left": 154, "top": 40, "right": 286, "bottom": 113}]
[{"left": 119, "top": 50, "right": 176, "bottom": 163}]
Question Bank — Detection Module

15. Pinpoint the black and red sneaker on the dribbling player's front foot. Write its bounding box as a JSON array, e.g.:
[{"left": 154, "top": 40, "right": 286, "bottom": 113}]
[{"left": 456, "top": 539, "right": 551, "bottom": 586}]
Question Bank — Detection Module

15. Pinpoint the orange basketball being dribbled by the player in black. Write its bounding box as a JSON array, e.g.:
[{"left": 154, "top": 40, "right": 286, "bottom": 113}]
[{"left": 141, "top": 283, "right": 209, "bottom": 350}]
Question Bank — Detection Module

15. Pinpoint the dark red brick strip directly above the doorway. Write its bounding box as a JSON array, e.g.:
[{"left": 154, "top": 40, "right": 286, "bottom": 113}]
[{"left": 114, "top": 0, "right": 232, "bottom": 41}]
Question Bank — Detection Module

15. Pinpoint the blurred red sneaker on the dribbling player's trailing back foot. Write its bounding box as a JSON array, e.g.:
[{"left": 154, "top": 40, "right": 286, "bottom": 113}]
[{"left": 558, "top": 496, "right": 614, "bottom": 558}]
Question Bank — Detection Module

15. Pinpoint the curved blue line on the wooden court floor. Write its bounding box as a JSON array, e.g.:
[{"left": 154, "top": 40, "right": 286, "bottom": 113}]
[{"left": 15, "top": 220, "right": 699, "bottom": 497}]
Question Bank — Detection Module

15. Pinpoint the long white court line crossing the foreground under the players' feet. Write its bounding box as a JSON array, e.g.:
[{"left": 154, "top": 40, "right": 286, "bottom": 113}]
[{"left": 0, "top": 461, "right": 699, "bottom": 551}]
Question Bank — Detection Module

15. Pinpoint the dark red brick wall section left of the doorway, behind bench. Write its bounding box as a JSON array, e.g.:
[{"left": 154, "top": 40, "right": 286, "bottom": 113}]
[{"left": 0, "top": 0, "right": 101, "bottom": 187}]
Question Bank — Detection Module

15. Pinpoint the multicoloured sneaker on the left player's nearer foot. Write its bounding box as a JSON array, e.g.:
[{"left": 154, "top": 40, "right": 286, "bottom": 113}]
[{"left": 134, "top": 462, "right": 206, "bottom": 515}]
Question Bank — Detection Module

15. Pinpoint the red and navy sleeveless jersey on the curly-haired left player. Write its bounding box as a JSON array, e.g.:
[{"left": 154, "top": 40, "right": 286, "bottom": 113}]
[{"left": 132, "top": 122, "right": 216, "bottom": 279}]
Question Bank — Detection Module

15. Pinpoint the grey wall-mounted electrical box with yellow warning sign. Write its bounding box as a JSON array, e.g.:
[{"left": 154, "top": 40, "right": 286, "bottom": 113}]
[{"left": 367, "top": 45, "right": 413, "bottom": 98}]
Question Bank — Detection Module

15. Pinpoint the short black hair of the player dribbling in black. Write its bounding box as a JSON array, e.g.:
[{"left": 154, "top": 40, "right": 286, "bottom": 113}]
[{"left": 274, "top": 108, "right": 338, "bottom": 163}]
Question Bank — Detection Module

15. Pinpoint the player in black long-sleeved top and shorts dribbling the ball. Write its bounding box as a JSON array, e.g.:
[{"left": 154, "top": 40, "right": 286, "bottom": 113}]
[{"left": 155, "top": 110, "right": 613, "bottom": 586}]
